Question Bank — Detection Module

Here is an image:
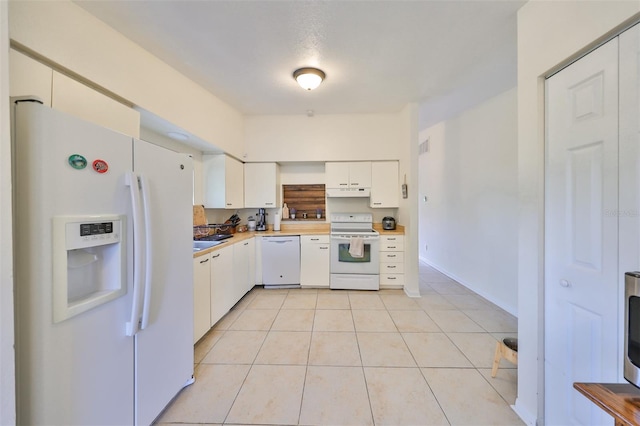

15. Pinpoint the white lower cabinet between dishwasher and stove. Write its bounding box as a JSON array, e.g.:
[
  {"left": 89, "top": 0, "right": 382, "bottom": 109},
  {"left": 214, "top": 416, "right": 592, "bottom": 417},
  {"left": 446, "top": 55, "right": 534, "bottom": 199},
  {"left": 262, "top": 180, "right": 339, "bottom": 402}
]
[{"left": 300, "top": 235, "right": 331, "bottom": 288}]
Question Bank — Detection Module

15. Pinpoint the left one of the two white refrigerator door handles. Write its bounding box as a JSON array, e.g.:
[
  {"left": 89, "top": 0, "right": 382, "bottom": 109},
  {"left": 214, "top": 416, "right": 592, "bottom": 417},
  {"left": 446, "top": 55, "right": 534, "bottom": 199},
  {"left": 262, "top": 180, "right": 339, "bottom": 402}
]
[{"left": 125, "top": 172, "right": 145, "bottom": 336}]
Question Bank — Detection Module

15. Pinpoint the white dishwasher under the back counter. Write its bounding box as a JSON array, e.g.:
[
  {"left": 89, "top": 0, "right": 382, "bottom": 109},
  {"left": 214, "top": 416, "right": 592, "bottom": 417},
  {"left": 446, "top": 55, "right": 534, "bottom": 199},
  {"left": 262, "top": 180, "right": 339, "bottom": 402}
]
[{"left": 262, "top": 235, "right": 300, "bottom": 288}]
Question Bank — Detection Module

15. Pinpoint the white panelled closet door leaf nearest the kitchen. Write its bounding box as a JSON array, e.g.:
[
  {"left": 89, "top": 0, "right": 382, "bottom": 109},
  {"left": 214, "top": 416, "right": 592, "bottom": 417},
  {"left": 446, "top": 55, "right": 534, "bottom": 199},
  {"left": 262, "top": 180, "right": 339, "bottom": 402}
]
[{"left": 545, "top": 39, "right": 620, "bottom": 425}]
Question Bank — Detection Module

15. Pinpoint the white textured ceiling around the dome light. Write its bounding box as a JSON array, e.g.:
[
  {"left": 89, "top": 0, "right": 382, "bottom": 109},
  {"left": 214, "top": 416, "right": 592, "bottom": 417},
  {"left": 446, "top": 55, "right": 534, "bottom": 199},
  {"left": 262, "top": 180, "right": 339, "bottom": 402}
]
[{"left": 76, "top": 0, "right": 525, "bottom": 128}]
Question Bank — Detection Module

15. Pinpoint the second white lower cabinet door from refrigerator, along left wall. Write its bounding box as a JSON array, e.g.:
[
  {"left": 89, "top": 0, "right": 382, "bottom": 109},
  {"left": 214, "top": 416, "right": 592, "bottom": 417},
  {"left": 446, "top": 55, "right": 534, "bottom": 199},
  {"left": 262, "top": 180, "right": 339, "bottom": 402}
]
[{"left": 209, "top": 246, "right": 236, "bottom": 327}]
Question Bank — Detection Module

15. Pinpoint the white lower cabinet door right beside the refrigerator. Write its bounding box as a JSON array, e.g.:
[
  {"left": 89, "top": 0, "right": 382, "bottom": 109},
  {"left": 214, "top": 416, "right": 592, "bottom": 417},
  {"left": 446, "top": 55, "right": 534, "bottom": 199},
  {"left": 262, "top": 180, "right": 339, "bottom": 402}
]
[{"left": 193, "top": 254, "right": 211, "bottom": 343}]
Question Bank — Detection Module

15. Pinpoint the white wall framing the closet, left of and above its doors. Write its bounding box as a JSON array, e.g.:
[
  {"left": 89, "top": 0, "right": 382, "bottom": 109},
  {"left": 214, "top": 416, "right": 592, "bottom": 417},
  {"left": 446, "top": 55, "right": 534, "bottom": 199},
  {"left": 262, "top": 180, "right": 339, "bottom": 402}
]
[{"left": 515, "top": 0, "right": 640, "bottom": 425}]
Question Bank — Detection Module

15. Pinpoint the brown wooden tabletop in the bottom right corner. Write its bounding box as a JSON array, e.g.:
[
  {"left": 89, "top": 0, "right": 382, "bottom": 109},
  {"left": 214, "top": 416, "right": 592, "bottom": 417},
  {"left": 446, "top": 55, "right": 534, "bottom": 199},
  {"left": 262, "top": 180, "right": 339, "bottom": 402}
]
[{"left": 573, "top": 383, "right": 640, "bottom": 426}]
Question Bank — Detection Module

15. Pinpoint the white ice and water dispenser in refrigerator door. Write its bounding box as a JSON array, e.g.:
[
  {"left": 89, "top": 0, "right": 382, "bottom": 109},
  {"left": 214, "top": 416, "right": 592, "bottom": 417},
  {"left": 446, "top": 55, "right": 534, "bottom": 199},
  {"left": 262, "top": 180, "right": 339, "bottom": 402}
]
[{"left": 53, "top": 215, "right": 127, "bottom": 322}]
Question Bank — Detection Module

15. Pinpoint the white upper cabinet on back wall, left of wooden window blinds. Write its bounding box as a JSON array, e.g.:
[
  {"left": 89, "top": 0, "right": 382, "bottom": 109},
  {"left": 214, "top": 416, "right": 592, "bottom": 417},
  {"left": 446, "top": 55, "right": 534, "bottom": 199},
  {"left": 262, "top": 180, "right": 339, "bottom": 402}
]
[{"left": 244, "top": 163, "right": 280, "bottom": 208}]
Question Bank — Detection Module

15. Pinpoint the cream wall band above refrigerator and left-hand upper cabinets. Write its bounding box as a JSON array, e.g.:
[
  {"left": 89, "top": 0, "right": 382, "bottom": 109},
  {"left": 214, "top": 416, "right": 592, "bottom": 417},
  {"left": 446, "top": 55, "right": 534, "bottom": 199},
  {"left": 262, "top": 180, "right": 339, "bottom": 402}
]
[{"left": 9, "top": 1, "right": 244, "bottom": 158}]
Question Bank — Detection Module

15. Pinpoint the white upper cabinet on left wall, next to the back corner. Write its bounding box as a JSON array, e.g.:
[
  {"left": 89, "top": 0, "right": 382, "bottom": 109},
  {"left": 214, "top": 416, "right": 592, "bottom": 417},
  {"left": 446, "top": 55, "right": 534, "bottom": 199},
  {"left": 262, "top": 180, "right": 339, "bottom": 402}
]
[{"left": 202, "top": 154, "right": 244, "bottom": 209}]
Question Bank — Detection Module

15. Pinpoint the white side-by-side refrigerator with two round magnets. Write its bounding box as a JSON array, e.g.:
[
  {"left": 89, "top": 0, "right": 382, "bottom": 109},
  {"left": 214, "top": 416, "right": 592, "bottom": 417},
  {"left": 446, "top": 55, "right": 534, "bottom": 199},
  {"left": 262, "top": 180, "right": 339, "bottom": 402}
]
[{"left": 12, "top": 101, "right": 193, "bottom": 425}]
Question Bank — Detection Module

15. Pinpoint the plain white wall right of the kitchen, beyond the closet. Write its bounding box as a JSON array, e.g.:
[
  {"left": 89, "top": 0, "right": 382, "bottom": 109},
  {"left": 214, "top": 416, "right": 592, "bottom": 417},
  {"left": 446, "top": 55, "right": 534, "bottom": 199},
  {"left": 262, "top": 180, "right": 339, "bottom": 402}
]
[{"left": 418, "top": 88, "right": 518, "bottom": 314}]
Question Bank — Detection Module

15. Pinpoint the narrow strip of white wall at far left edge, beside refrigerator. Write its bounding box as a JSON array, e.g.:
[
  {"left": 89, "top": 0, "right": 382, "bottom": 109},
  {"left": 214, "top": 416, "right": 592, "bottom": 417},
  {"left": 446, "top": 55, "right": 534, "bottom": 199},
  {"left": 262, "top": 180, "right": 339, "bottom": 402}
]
[{"left": 0, "top": 1, "right": 16, "bottom": 425}]
